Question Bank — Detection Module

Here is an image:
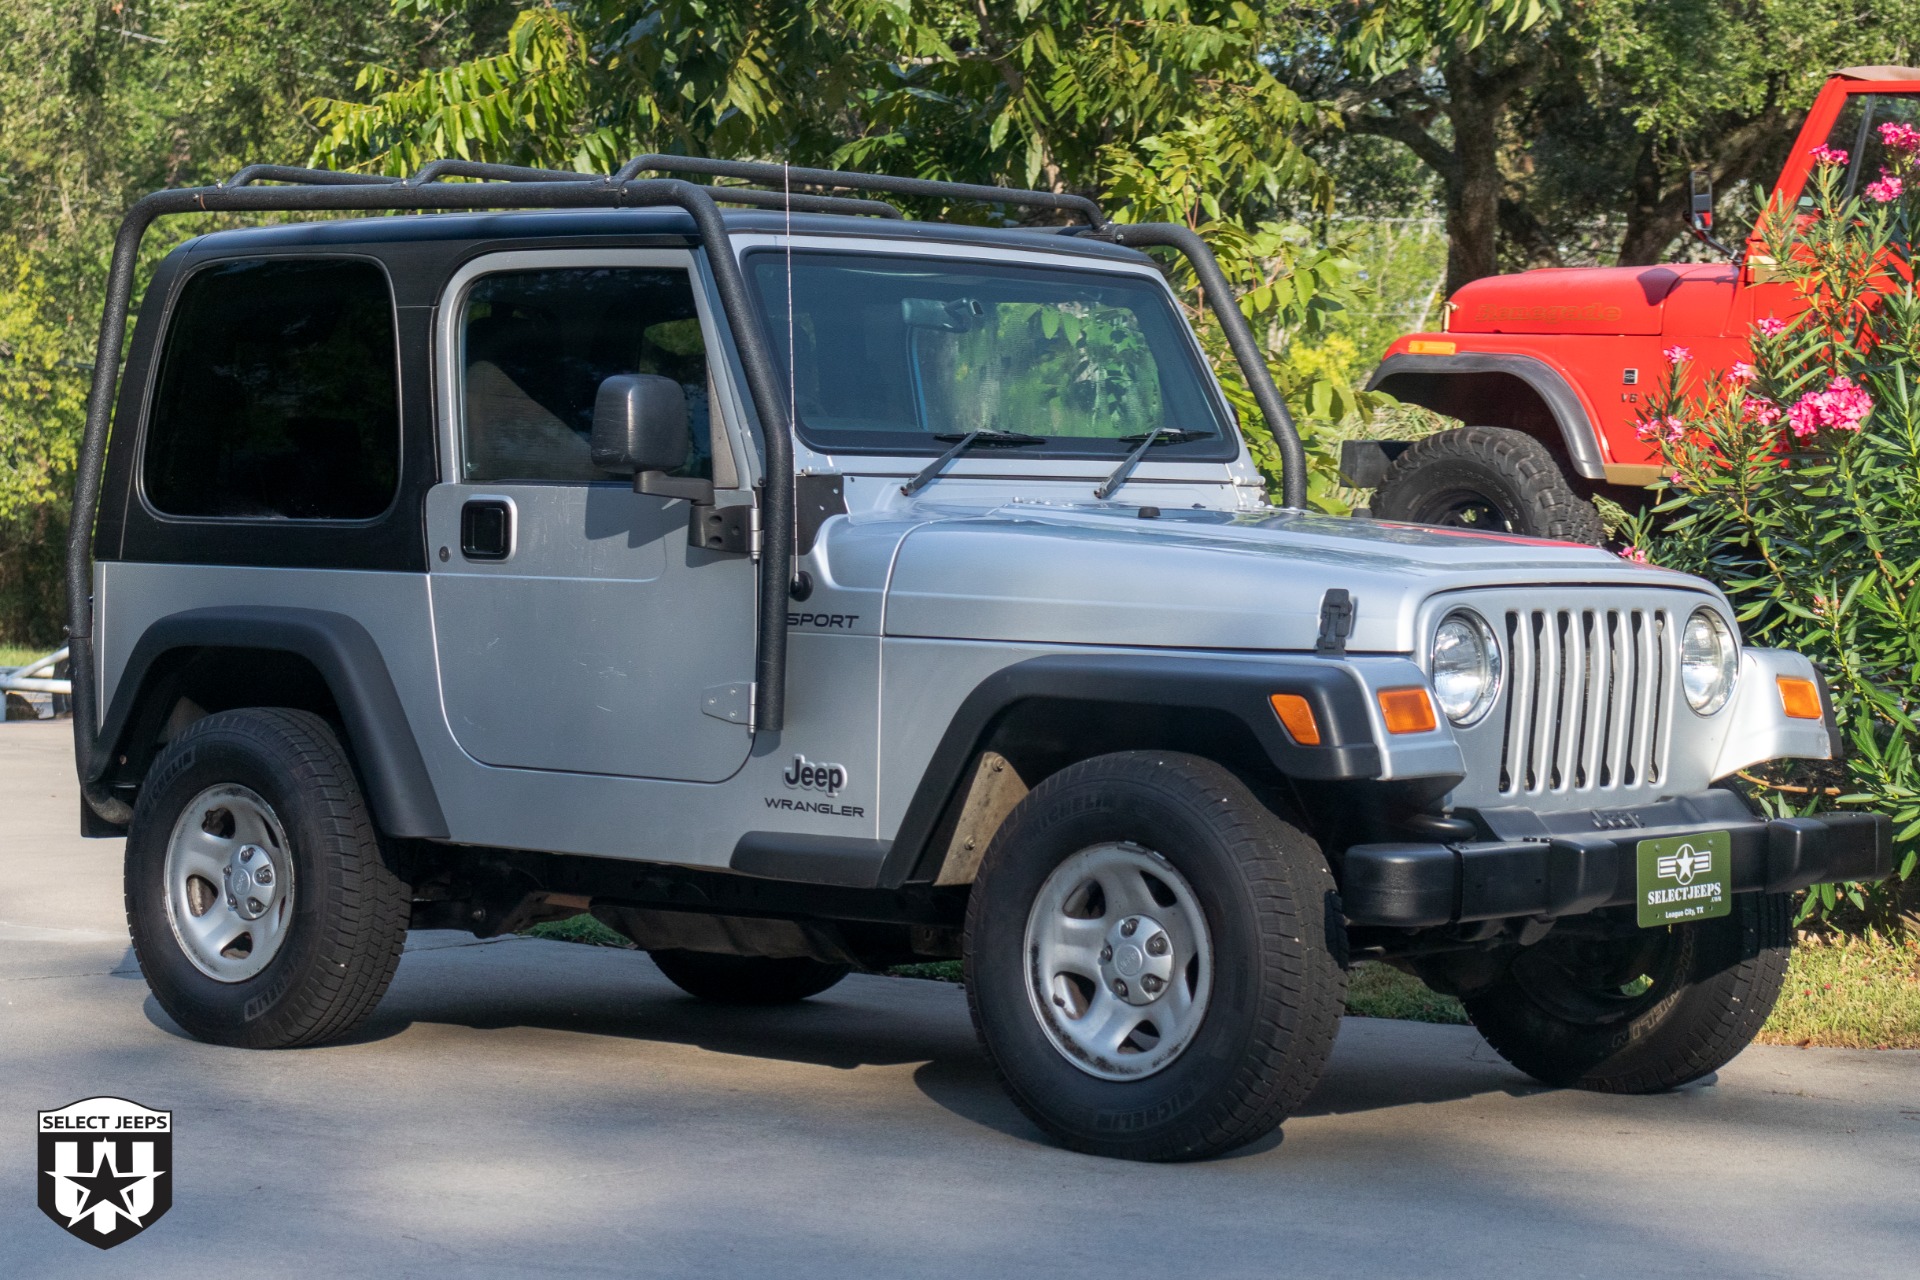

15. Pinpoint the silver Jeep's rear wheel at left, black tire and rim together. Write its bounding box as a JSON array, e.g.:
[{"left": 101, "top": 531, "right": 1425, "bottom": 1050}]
[{"left": 127, "top": 708, "right": 411, "bottom": 1048}]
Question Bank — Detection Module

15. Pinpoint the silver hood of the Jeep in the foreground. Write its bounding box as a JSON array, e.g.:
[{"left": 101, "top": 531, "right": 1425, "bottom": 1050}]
[{"left": 885, "top": 503, "right": 1711, "bottom": 652}]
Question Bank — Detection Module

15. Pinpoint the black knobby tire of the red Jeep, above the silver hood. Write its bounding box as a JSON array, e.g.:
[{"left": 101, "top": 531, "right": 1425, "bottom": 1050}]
[{"left": 1371, "top": 426, "right": 1607, "bottom": 547}]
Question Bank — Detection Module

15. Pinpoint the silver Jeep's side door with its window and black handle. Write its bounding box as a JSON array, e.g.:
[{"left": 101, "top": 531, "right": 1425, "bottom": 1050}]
[{"left": 426, "top": 249, "right": 755, "bottom": 783}]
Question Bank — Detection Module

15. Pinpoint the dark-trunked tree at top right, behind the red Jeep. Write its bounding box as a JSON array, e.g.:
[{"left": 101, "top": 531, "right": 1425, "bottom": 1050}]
[{"left": 1269, "top": 0, "right": 1920, "bottom": 292}]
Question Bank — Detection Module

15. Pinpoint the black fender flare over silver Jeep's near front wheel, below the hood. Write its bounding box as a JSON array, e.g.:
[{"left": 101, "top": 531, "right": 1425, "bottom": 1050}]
[{"left": 877, "top": 654, "right": 1384, "bottom": 887}]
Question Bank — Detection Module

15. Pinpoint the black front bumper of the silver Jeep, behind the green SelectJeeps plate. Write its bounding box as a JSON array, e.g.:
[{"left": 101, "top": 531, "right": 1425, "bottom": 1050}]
[{"left": 1336, "top": 791, "right": 1893, "bottom": 929}]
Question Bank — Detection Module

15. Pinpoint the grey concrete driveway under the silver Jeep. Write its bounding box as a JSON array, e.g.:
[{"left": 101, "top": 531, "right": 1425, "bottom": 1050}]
[{"left": 11, "top": 723, "right": 1920, "bottom": 1280}]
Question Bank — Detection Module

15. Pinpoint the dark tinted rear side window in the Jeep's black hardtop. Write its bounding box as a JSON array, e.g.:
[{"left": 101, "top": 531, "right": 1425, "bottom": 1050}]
[{"left": 146, "top": 257, "right": 399, "bottom": 520}]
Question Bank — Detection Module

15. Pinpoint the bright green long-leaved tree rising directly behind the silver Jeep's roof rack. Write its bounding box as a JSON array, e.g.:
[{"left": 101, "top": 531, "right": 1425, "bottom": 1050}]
[{"left": 313, "top": 0, "right": 1382, "bottom": 503}]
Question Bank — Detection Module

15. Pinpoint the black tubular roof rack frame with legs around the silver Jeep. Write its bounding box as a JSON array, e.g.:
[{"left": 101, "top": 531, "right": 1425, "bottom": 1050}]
[{"left": 67, "top": 155, "right": 1308, "bottom": 825}]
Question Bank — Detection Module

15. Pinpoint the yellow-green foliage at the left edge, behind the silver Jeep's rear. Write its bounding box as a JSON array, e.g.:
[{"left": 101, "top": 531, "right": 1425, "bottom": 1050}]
[{"left": 0, "top": 0, "right": 511, "bottom": 643}]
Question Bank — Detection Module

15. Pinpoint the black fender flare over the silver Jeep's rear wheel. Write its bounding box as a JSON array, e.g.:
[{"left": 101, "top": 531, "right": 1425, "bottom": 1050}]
[{"left": 84, "top": 606, "right": 447, "bottom": 839}]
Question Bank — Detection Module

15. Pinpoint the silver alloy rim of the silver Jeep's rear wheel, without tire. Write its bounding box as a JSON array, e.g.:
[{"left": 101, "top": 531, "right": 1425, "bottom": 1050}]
[{"left": 161, "top": 783, "right": 294, "bottom": 983}]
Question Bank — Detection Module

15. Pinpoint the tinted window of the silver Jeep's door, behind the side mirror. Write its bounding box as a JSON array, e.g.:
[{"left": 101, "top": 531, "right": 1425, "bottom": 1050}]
[{"left": 463, "top": 267, "right": 712, "bottom": 482}]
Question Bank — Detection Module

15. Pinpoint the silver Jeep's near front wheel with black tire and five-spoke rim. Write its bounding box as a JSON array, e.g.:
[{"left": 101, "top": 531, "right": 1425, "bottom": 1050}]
[{"left": 964, "top": 750, "right": 1346, "bottom": 1161}]
